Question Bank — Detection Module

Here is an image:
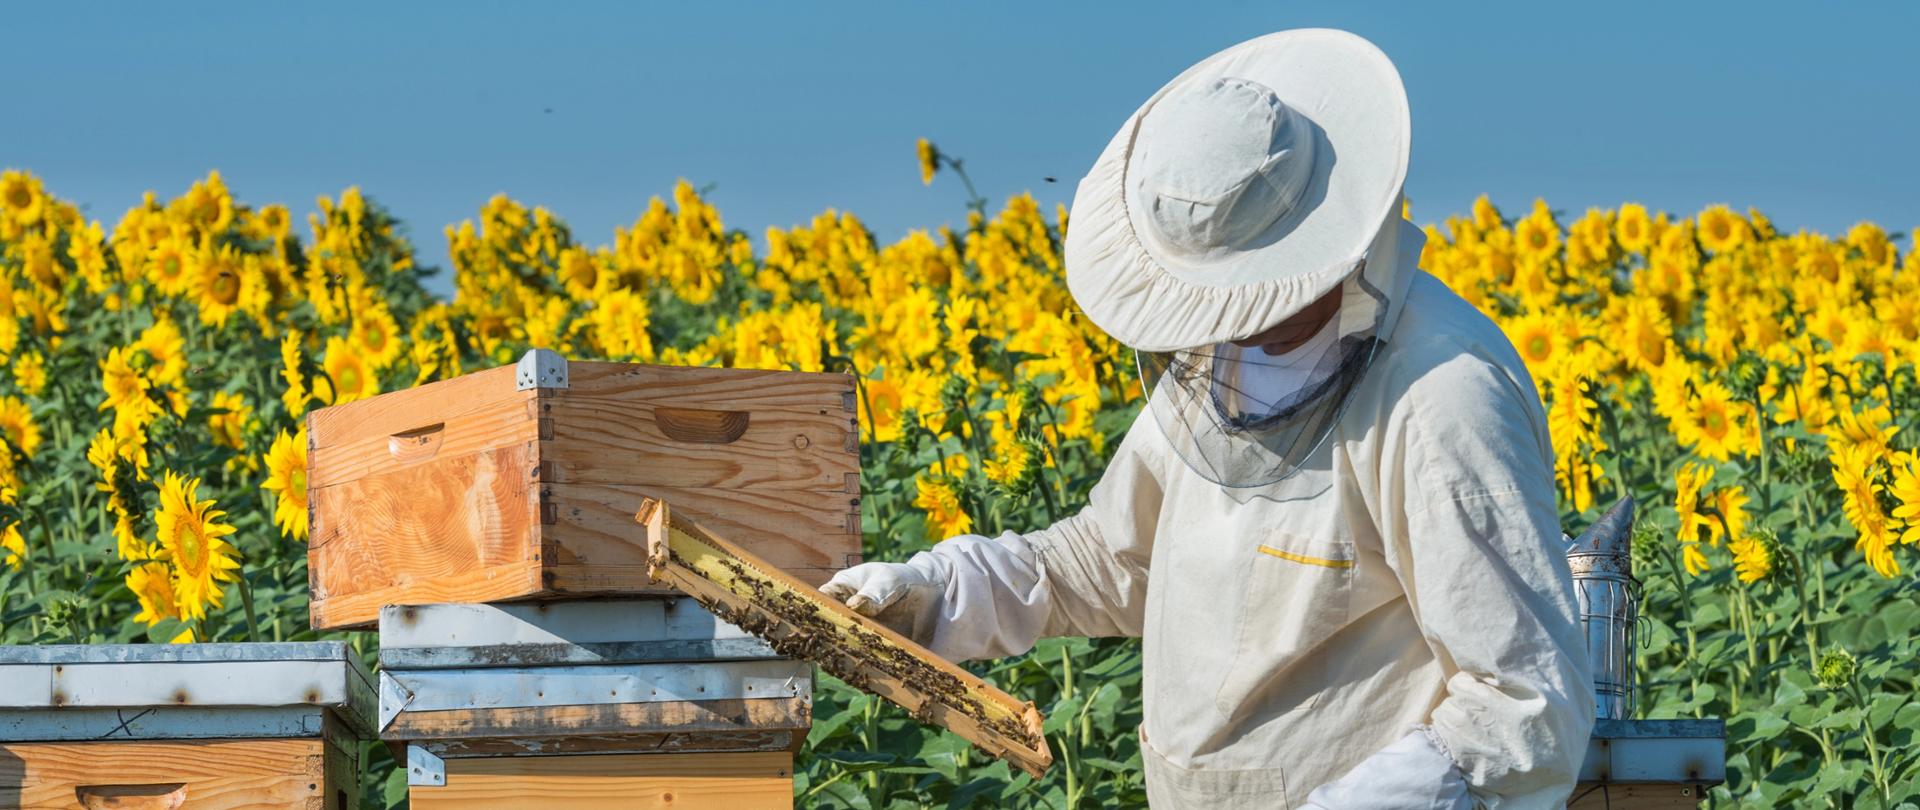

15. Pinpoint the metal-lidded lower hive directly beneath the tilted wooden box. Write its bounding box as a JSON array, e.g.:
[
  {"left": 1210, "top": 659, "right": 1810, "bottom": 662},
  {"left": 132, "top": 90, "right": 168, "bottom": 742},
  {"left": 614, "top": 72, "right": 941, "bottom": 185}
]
[{"left": 378, "top": 597, "right": 812, "bottom": 810}]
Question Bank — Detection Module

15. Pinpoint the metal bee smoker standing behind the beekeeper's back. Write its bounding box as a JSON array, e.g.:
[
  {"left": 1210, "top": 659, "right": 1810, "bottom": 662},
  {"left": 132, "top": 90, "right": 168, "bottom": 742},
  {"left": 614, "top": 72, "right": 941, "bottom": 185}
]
[{"left": 1561, "top": 497, "right": 1640, "bottom": 720}]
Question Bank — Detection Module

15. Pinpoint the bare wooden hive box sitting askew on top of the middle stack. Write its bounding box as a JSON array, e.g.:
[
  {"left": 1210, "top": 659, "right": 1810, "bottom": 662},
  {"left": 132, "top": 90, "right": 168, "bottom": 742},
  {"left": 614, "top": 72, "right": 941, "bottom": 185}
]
[{"left": 307, "top": 349, "right": 860, "bottom": 630}]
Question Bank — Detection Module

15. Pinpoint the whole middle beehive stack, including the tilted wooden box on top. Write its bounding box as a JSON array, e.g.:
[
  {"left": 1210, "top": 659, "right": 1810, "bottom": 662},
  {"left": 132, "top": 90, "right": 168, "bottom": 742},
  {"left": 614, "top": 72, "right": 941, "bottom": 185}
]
[{"left": 309, "top": 351, "right": 860, "bottom": 810}]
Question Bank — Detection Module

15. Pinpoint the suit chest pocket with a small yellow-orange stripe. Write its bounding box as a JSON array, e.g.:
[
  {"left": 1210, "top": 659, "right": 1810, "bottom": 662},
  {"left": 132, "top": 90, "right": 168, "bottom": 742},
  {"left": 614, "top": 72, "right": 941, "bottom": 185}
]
[{"left": 1215, "top": 532, "right": 1356, "bottom": 720}]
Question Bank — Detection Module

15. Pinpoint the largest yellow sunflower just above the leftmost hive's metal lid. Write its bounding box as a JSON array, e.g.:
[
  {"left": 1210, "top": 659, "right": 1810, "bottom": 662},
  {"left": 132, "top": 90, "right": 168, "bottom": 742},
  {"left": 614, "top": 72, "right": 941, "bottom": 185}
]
[{"left": 154, "top": 470, "right": 240, "bottom": 618}]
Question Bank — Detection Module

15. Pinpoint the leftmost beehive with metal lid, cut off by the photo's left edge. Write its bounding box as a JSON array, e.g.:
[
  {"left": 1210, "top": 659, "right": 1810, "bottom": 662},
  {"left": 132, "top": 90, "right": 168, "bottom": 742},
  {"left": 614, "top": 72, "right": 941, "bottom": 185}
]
[{"left": 0, "top": 641, "right": 376, "bottom": 810}]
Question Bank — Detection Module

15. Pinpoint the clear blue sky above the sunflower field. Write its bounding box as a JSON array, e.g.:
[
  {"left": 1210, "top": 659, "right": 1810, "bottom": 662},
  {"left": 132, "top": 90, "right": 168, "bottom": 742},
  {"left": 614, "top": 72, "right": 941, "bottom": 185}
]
[{"left": 0, "top": 0, "right": 1920, "bottom": 293}]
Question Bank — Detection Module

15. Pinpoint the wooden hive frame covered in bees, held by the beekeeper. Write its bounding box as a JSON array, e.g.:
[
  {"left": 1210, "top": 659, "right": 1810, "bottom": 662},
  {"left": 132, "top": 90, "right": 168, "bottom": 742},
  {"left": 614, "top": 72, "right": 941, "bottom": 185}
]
[{"left": 634, "top": 499, "right": 1054, "bottom": 775}]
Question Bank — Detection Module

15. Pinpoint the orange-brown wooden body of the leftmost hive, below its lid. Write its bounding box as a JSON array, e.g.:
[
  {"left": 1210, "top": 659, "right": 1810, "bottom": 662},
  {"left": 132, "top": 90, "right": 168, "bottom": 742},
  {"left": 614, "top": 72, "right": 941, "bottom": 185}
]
[{"left": 0, "top": 737, "right": 326, "bottom": 810}]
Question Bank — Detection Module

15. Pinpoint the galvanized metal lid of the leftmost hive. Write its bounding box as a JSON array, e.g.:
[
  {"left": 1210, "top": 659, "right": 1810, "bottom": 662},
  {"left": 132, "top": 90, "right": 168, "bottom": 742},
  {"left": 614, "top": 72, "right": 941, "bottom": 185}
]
[{"left": 0, "top": 641, "right": 378, "bottom": 735}]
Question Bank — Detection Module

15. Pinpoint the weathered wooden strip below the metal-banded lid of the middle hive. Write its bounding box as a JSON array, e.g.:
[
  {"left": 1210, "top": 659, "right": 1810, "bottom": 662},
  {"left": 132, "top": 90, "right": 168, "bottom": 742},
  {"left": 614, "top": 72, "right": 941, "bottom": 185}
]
[{"left": 380, "top": 695, "right": 814, "bottom": 741}]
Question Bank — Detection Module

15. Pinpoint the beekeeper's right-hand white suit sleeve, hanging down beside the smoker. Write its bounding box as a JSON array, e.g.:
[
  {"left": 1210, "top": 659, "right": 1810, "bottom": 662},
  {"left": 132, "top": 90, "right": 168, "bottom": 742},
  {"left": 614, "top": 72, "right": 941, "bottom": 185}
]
[{"left": 1380, "top": 351, "right": 1594, "bottom": 808}]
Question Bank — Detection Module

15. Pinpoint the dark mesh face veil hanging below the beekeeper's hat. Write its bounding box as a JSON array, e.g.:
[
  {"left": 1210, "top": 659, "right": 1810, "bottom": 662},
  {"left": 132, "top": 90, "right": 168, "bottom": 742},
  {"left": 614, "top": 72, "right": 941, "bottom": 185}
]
[{"left": 1135, "top": 217, "right": 1419, "bottom": 488}]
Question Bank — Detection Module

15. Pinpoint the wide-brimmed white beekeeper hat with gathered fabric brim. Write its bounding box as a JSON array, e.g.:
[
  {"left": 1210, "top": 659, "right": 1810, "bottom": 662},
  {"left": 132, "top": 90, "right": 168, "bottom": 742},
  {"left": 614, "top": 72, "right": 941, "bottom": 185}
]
[{"left": 1066, "top": 29, "right": 1411, "bottom": 351}]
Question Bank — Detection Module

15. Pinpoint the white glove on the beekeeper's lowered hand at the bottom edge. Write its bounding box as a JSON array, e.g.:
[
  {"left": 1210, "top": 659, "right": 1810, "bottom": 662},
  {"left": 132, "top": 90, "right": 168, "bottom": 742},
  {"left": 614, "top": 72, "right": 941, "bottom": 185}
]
[{"left": 1304, "top": 729, "right": 1476, "bottom": 810}]
